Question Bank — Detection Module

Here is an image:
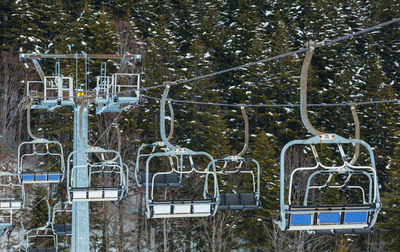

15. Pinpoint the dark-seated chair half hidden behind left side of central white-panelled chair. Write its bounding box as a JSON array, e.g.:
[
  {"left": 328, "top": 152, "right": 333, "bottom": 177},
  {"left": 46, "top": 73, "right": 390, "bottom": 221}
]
[{"left": 135, "top": 101, "right": 183, "bottom": 187}]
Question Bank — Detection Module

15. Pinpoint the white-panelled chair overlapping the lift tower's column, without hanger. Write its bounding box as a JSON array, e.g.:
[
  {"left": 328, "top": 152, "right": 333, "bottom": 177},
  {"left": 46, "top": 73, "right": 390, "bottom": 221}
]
[{"left": 67, "top": 146, "right": 128, "bottom": 202}]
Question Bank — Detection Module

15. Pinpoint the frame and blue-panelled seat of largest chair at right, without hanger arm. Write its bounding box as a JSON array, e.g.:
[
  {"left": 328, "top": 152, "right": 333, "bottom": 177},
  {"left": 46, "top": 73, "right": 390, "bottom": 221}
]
[{"left": 277, "top": 134, "right": 382, "bottom": 233}]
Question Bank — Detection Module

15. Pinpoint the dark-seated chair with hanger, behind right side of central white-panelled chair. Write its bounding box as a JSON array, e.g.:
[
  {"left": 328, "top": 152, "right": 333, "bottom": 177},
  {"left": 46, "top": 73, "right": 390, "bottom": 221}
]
[{"left": 204, "top": 107, "right": 260, "bottom": 210}]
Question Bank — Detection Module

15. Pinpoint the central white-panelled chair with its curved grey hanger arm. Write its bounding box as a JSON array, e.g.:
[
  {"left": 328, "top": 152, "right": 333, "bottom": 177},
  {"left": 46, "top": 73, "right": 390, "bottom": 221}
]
[{"left": 145, "top": 83, "right": 220, "bottom": 218}]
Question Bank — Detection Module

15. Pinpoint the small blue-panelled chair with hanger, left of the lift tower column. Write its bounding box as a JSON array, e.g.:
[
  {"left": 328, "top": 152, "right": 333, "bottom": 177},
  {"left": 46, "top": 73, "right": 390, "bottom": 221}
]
[{"left": 18, "top": 100, "right": 65, "bottom": 184}]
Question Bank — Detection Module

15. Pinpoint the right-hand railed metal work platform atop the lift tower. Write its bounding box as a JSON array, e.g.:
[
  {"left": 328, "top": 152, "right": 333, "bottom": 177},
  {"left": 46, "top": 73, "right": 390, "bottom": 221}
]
[{"left": 95, "top": 58, "right": 143, "bottom": 114}]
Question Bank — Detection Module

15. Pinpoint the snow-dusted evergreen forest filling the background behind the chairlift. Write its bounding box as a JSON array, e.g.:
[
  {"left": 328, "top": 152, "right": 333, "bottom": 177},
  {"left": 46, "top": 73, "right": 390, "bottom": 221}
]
[{"left": 0, "top": 0, "right": 400, "bottom": 251}]
